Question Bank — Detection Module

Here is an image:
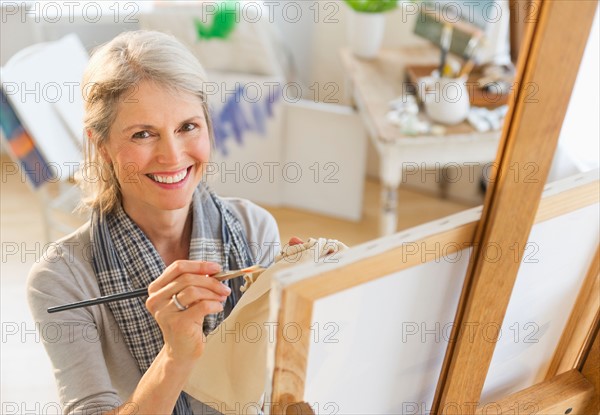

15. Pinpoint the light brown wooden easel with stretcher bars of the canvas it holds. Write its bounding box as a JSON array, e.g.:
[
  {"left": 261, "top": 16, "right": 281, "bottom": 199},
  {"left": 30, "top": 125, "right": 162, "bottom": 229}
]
[{"left": 271, "top": 0, "right": 600, "bottom": 414}]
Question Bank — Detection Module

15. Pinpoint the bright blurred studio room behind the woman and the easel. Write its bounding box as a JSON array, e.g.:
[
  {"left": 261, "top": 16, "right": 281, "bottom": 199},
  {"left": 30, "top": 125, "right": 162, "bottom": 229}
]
[{"left": 0, "top": 0, "right": 600, "bottom": 414}]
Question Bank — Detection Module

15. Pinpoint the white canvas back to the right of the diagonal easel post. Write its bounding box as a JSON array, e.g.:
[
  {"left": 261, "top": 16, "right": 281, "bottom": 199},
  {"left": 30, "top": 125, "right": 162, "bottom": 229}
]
[{"left": 481, "top": 204, "right": 600, "bottom": 403}]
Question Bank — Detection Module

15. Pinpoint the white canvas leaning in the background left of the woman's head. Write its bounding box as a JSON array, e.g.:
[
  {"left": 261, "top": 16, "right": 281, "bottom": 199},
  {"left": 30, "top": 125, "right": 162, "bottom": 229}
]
[{"left": 2, "top": 35, "right": 88, "bottom": 180}]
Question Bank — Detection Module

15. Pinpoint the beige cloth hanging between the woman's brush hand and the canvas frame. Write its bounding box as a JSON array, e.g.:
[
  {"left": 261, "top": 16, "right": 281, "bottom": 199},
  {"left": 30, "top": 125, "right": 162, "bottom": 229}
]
[{"left": 184, "top": 238, "right": 347, "bottom": 414}]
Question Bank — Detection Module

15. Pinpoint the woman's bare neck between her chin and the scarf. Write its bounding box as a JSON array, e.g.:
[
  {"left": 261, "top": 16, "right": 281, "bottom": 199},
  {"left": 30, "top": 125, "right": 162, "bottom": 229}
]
[{"left": 123, "top": 201, "right": 192, "bottom": 266}]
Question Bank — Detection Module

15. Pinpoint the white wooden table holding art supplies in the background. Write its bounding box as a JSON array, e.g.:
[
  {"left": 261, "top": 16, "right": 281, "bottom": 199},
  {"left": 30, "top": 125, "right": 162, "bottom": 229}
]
[{"left": 341, "top": 47, "right": 501, "bottom": 235}]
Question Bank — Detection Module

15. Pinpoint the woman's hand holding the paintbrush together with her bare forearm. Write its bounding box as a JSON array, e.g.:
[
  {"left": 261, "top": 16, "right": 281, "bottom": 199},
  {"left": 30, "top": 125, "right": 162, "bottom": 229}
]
[{"left": 106, "top": 261, "right": 231, "bottom": 415}]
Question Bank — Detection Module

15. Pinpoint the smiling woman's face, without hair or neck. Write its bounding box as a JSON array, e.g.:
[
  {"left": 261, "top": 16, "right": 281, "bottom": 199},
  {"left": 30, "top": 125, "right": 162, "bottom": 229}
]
[{"left": 100, "top": 81, "right": 210, "bottom": 218}]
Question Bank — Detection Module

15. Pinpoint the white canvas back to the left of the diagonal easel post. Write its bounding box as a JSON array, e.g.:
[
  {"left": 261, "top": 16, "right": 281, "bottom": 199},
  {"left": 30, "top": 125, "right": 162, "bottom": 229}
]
[{"left": 305, "top": 250, "right": 469, "bottom": 414}]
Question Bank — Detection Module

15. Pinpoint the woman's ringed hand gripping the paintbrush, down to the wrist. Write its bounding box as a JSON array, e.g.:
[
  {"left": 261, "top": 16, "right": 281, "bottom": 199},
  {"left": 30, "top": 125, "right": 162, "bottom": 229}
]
[{"left": 146, "top": 260, "right": 231, "bottom": 364}]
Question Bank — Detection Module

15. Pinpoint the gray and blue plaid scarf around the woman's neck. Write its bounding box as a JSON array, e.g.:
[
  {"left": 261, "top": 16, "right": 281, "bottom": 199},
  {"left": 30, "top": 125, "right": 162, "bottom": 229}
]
[{"left": 91, "top": 185, "right": 255, "bottom": 415}]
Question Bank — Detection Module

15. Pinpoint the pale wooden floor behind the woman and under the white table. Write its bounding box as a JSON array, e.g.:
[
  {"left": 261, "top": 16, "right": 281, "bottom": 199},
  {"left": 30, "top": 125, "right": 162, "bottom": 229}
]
[{"left": 0, "top": 154, "right": 469, "bottom": 406}]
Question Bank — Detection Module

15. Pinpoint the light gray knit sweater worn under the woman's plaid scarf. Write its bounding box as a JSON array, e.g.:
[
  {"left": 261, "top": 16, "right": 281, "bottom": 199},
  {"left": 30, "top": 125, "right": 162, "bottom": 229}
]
[{"left": 27, "top": 198, "right": 281, "bottom": 415}]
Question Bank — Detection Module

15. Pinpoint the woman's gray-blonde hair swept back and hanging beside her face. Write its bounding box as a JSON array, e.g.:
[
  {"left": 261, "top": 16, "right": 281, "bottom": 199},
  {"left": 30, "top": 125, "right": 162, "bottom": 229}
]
[{"left": 80, "top": 30, "right": 214, "bottom": 213}]
